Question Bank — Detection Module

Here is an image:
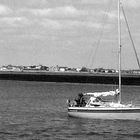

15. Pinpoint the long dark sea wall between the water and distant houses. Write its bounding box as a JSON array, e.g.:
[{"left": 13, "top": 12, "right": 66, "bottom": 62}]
[{"left": 0, "top": 71, "right": 140, "bottom": 85}]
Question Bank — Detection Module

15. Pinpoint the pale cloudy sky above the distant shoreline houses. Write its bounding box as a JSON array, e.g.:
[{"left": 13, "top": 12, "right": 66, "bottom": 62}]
[{"left": 0, "top": 0, "right": 140, "bottom": 69}]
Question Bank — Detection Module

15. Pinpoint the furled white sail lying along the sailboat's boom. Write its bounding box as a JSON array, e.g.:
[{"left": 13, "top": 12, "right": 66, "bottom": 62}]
[{"left": 84, "top": 89, "right": 119, "bottom": 97}]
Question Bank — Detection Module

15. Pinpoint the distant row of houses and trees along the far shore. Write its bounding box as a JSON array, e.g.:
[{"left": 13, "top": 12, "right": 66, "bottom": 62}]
[{"left": 0, "top": 65, "right": 140, "bottom": 74}]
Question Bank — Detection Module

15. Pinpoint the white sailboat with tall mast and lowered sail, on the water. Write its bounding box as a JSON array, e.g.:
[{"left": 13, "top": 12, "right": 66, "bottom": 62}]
[{"left": 67, "top": 0, "right": 140, "bottom": 120}]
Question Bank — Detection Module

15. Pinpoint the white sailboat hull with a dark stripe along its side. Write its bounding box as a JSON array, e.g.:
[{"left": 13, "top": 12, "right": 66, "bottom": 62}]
[{"left": 68, "top": 107, "right": 140, "bottom": 120}]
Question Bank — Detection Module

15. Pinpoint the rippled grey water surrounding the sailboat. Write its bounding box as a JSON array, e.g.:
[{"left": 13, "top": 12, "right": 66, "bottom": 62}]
[{"left": 0, "top": 81, "right": 140, "bottom": 140}]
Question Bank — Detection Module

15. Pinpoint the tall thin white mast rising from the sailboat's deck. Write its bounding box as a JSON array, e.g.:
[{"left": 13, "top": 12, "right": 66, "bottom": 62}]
[{"left": 118, "top": 0, "right": 121, "bottom": 103}]
